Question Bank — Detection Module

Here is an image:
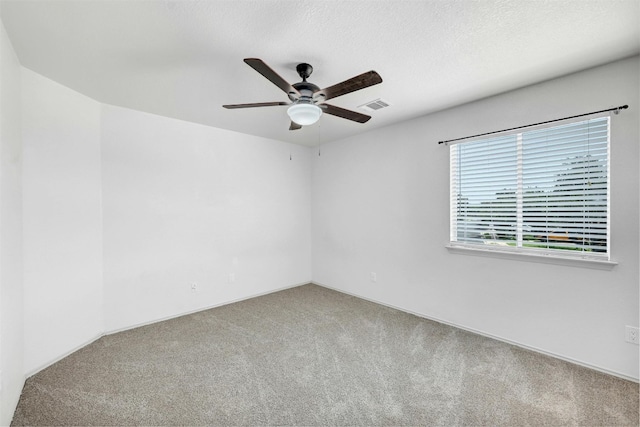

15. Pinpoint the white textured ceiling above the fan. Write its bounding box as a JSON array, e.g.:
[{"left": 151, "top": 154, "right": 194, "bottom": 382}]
[{"left": 0, "top": 0, "right": 640, "bottom": 145}]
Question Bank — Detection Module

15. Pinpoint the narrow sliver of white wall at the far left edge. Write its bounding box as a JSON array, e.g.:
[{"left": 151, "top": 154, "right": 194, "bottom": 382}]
[{"left": 0, "top": 18, "right": 24, "bottom": 425}]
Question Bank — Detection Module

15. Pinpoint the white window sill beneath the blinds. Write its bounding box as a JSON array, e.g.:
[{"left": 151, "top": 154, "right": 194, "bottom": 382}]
[{"left": 446, "top": 244, "right": 618, "bottom": 270}]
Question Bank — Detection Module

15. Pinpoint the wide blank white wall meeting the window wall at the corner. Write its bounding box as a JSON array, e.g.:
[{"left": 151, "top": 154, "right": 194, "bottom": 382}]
[{"left": 102, "top": 106, "right": 311, "bottom": 331}]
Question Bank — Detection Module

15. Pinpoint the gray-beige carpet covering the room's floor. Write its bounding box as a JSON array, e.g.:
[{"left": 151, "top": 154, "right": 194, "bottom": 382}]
[{"left": 12, "top": 285, "right": 638, "bottom": 426}]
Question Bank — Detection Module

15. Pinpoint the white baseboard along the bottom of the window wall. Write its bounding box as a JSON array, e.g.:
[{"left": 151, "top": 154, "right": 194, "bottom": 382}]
[{"left": 311, "top": 281, "right": 640, "bottom": 383}]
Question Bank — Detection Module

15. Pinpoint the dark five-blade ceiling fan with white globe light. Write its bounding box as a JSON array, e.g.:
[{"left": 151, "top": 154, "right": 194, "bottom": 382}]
[{"left": 223, "top": 58, "right": 382, "bottom": 130}]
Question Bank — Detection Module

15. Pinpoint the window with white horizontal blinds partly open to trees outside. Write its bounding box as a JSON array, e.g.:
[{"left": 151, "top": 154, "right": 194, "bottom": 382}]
[{"left": 450, "top": 117, "right": 609, "bottom": 260}]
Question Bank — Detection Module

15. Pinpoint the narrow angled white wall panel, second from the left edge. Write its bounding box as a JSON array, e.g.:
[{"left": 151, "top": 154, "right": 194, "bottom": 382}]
[{"left": 22, "top": 69, "right": 103, "bottom": 373}]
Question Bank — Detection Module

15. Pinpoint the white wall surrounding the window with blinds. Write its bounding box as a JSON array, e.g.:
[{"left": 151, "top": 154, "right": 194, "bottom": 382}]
[{"left": 312, "top": 57, "right": 640, "bottom": 379}]
